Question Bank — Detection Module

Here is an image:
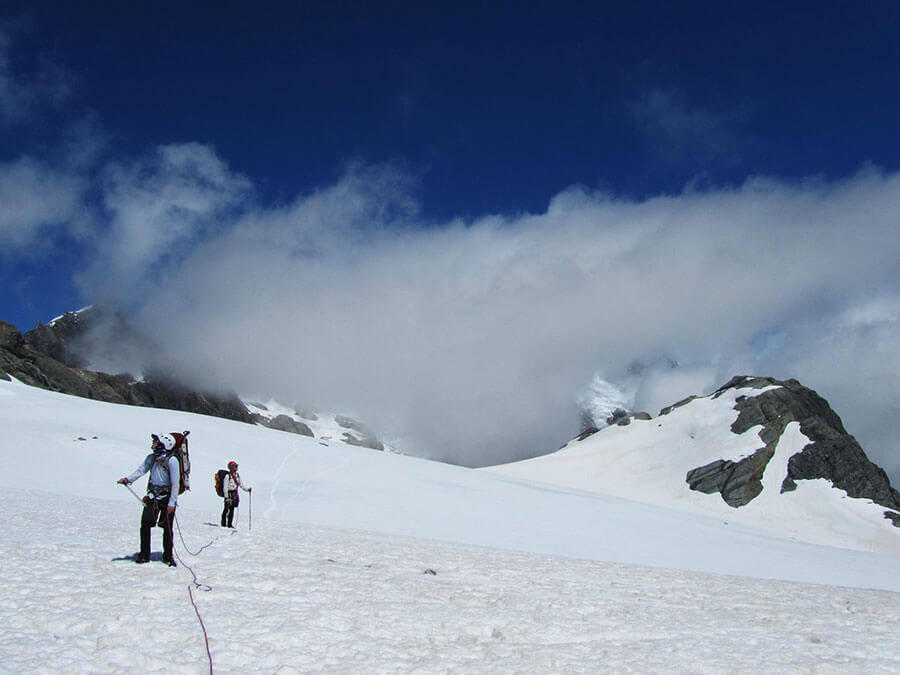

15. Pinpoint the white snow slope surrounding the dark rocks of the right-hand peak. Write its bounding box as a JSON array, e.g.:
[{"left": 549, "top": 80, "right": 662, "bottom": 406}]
[{"left": 484, "top": 387, "right": 900, "bottom": 555}]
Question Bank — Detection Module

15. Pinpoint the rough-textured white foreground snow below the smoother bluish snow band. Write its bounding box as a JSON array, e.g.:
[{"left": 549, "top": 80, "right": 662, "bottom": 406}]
[{"left": 0, "top": 489, "right": 900, "bottom": 673}]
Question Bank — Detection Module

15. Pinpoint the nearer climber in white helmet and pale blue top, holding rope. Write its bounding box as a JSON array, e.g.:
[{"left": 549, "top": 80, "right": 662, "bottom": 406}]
[{"left": 118, "top": 432, "right": 187, "bottom": 567}]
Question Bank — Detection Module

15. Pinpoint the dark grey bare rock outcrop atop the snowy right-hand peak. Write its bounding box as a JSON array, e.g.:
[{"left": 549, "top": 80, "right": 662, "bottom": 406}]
[{"left": 686, "top": 377, "right": 900, "bottom": 525}]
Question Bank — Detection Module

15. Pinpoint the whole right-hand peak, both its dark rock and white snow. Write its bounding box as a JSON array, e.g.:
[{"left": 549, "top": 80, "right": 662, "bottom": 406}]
[{"left": 484, "top": 376, "right": 900, "bottom": 550}]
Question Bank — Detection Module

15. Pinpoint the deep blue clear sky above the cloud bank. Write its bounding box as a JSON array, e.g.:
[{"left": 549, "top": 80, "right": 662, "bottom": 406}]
[{"left": 0, "top": 2, "right": 900, "bottom": 328}]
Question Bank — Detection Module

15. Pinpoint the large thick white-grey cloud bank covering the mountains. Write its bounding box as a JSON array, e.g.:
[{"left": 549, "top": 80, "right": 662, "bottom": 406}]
[{"left": 75, "top": 159, "right": 900, "bottom": 478}]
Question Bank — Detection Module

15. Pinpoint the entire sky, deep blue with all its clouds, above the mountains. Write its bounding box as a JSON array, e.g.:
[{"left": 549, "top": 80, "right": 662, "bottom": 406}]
[{"left": 0, "top": 1, "right": 900, "bottom": 471}]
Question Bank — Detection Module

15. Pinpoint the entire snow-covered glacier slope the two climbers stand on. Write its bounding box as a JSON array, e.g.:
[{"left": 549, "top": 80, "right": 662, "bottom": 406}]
[{"left": 0, "top": 382, "right": 900, "bottom": 673}]
